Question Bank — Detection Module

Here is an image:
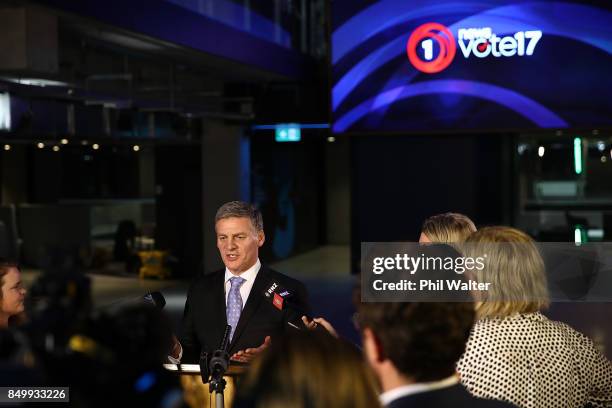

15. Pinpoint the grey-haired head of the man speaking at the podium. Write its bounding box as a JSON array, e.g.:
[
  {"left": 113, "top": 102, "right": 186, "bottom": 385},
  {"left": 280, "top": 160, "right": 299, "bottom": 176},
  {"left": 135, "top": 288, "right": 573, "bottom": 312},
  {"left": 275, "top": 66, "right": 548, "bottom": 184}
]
[{"left": 215, "top": 201, "right": 265, "bottom": 275}]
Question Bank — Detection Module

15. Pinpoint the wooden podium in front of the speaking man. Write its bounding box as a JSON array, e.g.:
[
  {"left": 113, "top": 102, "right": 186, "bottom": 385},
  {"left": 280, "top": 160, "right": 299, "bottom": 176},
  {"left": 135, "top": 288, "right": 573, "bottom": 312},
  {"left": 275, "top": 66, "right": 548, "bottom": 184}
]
[{"left": 164, "top": 363, "right": 247, "bottom": 408}]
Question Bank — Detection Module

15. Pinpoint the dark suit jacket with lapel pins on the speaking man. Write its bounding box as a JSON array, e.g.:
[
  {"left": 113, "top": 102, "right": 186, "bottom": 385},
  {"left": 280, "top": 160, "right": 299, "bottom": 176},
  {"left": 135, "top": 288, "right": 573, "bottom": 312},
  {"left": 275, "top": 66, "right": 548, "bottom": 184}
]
[{"left": 181, "top": 265, "right": 310, "bottom": 363}]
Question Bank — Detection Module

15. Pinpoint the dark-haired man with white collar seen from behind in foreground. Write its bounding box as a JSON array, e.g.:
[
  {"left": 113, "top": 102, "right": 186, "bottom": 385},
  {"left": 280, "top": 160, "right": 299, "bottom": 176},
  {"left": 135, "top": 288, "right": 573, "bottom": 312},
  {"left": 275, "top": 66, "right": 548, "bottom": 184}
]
[{"left": 359, "top": 302, "right": 512, "bottom": 408}]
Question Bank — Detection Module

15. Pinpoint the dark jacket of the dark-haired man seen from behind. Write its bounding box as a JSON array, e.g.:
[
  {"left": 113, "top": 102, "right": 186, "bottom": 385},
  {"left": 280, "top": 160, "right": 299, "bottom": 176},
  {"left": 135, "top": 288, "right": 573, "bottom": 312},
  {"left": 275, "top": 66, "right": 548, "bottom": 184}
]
[{"left": 385, "top": 384, "right": 514, "bottom": 408}]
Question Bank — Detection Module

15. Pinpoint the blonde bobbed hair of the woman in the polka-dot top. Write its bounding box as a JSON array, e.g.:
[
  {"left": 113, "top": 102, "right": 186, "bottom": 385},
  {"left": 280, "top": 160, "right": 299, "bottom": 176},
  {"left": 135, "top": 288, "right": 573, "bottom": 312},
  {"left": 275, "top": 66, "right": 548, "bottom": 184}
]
[{"left": 462, "top": 226, "right": 549, "bottom": 318}]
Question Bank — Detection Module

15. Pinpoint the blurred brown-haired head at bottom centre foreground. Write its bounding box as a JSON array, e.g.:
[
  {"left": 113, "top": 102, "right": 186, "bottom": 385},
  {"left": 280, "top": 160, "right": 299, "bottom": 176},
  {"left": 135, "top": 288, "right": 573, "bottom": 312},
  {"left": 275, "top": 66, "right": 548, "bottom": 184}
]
[{"left": 237, "top": 331, "right": 380, "bottom": 408}]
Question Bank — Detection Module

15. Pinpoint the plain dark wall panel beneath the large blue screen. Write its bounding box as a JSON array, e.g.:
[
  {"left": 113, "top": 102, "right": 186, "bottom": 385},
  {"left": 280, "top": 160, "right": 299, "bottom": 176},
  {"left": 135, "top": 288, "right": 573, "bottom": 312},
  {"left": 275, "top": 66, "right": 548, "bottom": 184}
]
[{"left": 351, "top": 135, "right": 512, "bottom": 272}]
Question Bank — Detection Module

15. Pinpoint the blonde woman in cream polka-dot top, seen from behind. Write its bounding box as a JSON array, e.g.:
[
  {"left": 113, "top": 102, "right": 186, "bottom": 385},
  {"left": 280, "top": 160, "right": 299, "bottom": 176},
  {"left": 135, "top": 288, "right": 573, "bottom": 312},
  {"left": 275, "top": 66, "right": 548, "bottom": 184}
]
[{"left": 457, "top": 227, "right": 612, "bottom": 408}]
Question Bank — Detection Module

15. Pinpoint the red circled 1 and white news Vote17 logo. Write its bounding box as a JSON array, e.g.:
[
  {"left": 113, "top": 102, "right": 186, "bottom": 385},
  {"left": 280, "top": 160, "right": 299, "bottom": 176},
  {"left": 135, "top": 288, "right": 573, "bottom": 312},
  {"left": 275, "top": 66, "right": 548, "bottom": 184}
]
[{"left": 406, "top": 23, "right": 542, "bottom": 74}]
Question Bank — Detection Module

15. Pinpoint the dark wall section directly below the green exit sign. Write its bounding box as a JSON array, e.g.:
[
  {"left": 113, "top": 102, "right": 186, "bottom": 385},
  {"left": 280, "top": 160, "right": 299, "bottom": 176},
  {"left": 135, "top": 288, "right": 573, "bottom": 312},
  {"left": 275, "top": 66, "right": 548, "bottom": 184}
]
[{"left": 251, "top": 131, "right": 327, "bottom": 262}]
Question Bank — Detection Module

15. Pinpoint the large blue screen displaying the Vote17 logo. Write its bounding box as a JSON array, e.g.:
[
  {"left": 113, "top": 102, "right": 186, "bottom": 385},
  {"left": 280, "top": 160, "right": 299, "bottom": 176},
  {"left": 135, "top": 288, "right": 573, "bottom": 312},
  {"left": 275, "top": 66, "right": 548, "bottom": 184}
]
[{"left": 332, "top": 0, "right": 612, "bottom": 132}]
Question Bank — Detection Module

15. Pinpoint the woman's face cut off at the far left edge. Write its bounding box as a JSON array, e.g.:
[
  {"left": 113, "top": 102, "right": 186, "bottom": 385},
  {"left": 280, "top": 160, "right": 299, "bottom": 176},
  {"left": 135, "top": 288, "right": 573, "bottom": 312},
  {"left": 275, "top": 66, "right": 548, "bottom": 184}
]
[{"left": 0, "top": 259, "right": 26, "bottom": 329}]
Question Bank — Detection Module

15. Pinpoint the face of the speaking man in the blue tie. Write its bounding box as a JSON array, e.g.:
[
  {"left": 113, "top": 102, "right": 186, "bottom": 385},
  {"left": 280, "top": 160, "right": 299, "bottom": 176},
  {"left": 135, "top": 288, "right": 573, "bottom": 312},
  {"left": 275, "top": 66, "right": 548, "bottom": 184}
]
[{"left": 215, "top": 217, "right": 265, "bottom": 275}]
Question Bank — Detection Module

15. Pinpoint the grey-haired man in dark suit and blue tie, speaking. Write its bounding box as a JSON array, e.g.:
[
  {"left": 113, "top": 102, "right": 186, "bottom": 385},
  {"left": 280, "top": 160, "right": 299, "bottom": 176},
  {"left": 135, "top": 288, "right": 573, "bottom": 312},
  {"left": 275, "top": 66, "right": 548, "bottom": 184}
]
[{"left": 171, "top": 201, "right": 310, "bottom": 362}]
